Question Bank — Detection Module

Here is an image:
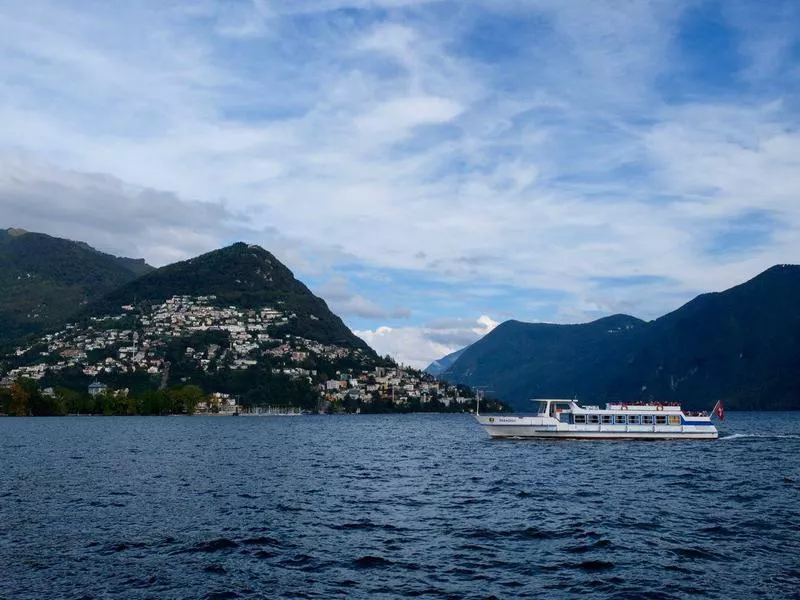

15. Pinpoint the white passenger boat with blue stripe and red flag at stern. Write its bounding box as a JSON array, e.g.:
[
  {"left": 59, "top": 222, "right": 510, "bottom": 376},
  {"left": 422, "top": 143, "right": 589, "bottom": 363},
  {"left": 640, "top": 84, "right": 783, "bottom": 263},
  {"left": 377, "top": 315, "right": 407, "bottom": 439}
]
[{"left": 475, "top": 399, "right": 724, "bottom": 440}]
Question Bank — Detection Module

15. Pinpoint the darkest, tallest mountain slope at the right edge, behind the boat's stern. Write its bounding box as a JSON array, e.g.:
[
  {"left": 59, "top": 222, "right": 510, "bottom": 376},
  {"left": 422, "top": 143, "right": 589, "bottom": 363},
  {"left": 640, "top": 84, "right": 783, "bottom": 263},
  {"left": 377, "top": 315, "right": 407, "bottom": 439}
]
[{"left": 609, "top": 265, "right": 800, "bottom": 410}]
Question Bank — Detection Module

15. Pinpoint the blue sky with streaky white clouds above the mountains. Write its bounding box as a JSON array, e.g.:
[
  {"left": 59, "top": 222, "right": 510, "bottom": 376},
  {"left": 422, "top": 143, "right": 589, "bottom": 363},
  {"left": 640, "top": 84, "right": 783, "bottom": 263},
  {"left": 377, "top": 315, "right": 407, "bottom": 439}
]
[{"left": 0, "top": 0, "right": 800, "bottom": 367}]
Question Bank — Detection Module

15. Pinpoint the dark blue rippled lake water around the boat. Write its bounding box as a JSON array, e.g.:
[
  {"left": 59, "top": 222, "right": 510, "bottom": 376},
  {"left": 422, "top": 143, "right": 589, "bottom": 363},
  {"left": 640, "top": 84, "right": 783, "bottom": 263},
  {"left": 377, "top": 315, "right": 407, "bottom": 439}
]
[{"left": 0, "top": 413, "right": 800, "bottom": 599}]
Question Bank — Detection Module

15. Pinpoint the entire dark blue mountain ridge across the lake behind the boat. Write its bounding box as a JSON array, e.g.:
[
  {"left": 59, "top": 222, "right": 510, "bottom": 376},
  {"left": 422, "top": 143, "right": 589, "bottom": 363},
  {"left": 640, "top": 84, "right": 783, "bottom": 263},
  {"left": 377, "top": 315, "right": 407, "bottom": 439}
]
[{"left": 442, "top": 265, "right": 800, "bottom": 410}]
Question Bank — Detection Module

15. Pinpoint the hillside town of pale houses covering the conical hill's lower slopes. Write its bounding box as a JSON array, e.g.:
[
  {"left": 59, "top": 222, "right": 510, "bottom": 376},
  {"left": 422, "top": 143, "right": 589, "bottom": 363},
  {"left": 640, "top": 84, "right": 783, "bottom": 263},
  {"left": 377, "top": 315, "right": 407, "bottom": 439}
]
[{"left": 0, "top": 295, "right": 484, "bottom": 414}]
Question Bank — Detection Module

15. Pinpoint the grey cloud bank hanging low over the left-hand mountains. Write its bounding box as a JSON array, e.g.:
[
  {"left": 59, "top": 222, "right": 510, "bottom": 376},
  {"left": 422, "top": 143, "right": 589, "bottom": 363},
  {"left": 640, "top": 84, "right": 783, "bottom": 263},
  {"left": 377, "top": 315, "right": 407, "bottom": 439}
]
[{"left": 0, "top": 155, "right": 247, "bottom": 265}]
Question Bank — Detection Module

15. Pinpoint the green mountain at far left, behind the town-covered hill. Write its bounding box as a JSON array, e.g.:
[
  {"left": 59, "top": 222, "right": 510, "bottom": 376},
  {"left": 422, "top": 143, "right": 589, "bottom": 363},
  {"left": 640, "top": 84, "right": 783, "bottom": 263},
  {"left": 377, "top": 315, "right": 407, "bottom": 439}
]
[{"left": 0, "top": 229, "right": 153, "bottom": 344}]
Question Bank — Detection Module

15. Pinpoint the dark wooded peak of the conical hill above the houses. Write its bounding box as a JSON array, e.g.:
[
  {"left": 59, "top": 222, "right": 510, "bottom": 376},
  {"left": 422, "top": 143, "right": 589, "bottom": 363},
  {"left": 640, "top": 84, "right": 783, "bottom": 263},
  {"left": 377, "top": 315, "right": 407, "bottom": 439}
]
[{"left": 81, "top": 242, "right": 371, "bottom": 352}]
